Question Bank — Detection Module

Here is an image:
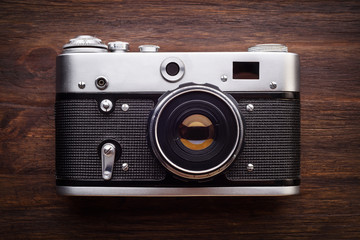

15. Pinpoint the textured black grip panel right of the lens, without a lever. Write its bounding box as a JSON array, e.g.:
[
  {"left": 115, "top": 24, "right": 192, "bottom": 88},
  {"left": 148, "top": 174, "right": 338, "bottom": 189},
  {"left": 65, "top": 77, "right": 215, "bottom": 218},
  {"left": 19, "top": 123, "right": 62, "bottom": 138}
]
[{"left": 226, "top": 99, "right": 300, "bottom": 181}]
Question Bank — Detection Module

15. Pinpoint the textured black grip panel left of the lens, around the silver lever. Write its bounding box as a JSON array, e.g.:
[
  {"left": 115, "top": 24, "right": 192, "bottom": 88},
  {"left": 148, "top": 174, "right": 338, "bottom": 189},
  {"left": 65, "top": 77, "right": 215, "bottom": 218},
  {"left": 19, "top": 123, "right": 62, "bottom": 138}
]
[{"left": 55, "top": 99, "right": 166, "bottom": 181}]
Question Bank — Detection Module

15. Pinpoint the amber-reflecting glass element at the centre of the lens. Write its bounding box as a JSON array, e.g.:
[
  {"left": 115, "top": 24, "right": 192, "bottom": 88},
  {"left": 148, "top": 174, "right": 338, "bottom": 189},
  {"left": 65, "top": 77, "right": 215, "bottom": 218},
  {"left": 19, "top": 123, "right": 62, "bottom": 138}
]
[{"left": 178, "top": 114, "right": 215, "bottom": 150}]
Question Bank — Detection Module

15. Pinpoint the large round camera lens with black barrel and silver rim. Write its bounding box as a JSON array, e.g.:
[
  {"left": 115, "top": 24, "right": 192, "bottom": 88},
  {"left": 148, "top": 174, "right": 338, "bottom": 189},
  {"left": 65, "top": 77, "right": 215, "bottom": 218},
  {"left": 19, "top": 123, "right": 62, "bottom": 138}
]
[{"left": 149, "top": 84, "right": 243, "bottom": 179}]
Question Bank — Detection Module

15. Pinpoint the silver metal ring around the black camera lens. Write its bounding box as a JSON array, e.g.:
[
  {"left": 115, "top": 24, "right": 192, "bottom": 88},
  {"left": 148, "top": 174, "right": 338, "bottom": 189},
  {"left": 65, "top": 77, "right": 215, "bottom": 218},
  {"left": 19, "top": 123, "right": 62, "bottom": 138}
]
[{"left": 149, "top": 85, "right": 244, "bottom": 179}]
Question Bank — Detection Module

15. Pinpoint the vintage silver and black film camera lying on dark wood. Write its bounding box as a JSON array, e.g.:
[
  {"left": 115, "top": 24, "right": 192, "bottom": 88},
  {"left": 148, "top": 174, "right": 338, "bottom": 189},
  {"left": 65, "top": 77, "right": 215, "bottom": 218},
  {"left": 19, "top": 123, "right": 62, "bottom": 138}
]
[{"left": 55, "top": 35, "right": 300, "bottom": 196}]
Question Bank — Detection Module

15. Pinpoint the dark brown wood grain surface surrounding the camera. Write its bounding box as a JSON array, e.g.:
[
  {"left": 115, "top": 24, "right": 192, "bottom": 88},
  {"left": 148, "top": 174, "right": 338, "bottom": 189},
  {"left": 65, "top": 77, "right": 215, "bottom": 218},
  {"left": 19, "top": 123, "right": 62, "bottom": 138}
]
[{"left": 0, "top": 0, "right": 360, "bottom": 239}]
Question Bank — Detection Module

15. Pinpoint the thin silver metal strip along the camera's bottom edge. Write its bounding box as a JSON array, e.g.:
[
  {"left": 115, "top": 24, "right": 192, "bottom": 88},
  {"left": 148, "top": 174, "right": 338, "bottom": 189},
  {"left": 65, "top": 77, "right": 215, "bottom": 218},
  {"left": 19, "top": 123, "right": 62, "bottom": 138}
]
[{"left": 56, "top": 186, "right": 300, "bottom": 197}]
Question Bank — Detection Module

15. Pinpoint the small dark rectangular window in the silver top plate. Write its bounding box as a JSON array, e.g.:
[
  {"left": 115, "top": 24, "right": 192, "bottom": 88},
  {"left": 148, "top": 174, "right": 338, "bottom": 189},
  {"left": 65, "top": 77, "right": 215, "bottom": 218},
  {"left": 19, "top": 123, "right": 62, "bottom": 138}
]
[{"left": 233, "top": 62, "right": 260, "bottom": 79}]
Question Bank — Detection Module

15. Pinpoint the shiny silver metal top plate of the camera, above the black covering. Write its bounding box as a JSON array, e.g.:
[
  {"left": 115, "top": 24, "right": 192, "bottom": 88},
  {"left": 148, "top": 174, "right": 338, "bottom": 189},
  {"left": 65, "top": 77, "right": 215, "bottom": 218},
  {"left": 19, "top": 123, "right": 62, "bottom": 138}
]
[{"left": 56, "top": 52, "right": 300, "bottom": 93}]
